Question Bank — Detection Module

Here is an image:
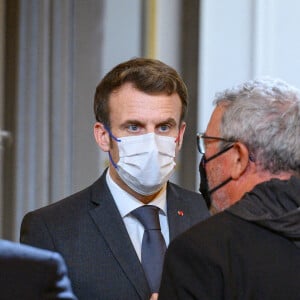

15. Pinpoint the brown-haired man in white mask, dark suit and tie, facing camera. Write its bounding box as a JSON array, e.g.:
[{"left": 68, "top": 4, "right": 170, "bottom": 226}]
[{"left": 21, "top": 58, "right": 209, "bottom": 300}]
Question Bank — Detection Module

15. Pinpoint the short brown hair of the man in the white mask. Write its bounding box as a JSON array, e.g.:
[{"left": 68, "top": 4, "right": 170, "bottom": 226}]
[{"left": 94, "top": 58, "right": 188, "bottom": 126}]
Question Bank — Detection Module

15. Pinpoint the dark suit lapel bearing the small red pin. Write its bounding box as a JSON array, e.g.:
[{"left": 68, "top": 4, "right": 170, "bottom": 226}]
[{"left": 167, "top": 183, "right": 197, "bottom": 241}]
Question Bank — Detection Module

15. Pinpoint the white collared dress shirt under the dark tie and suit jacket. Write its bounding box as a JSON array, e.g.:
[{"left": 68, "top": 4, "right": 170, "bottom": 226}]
[{"left": 106, "top": 170, "right": 170, "bottom": 260}]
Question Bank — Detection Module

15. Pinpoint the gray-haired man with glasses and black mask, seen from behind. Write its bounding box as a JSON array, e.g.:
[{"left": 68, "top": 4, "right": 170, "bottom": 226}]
[{"left": 159, "top": 78, "right": 300, "bottom": 300}]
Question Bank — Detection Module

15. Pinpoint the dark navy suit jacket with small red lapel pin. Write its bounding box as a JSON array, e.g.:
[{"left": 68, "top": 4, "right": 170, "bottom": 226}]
[{"left": 21, "top": 172, "right": 209, "bottom": 300}]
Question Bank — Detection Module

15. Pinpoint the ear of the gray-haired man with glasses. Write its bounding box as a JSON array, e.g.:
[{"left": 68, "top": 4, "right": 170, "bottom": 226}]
[{"left": 231, "top": 142, "right": 249, "bottom": 179}]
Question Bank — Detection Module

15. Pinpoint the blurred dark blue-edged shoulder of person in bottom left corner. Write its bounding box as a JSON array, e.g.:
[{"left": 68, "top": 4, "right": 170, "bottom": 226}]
[{"left": 0, "top": 240, "right": 77, "bottom": 300}]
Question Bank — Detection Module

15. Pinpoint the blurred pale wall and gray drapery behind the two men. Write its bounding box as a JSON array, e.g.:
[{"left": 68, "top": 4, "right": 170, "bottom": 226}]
[{"left": 0, "top": 0, "right": 300, "bottom": 240}]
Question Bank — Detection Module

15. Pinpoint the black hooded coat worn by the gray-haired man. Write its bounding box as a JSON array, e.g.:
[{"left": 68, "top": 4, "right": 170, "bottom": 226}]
[{"left": 159, "top": 178, "right": 300, "bottom": 300}]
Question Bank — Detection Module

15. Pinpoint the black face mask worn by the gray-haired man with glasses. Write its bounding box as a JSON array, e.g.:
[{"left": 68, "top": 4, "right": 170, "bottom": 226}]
[{"left": 199, "top": 145, "right": 233, "bottom": 208}]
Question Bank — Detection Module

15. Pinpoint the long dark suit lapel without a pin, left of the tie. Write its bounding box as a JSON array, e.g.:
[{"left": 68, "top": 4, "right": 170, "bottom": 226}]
[{"left": 90, "top": 173, "right": 150, "bottom": 299}]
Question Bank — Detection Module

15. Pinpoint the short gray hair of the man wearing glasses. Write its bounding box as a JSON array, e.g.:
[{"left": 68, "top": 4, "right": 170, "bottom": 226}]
[{"left": 214, "top": 78, "right": 300, "bottom": 174}]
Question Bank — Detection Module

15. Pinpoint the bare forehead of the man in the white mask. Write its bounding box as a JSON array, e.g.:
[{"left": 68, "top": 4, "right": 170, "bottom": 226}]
[{"left": 109, "top": 83, "right": 182, "bottom": 122}]
